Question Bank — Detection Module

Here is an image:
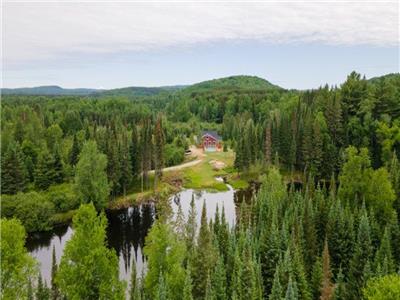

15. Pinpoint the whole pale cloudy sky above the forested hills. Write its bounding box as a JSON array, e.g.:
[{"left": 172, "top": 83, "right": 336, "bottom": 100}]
[{"left": 1, "top": 0, "right": 400, "bottom": 89}]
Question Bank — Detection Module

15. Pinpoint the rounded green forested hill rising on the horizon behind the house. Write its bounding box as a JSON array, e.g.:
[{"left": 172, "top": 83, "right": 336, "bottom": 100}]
[{"left": 183, "top": 75, "right": 282, "bottom": 92}]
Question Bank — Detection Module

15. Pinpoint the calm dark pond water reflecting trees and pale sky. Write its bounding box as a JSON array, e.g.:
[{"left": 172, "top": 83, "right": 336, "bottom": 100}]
[{"left": 26, "top": 185, "right": 251, "bottom": 284}]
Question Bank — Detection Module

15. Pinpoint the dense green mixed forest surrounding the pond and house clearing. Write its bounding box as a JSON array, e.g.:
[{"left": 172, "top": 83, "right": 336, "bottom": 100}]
[{"left": 1, "top": 72, "right": 400, "bottom": 300}]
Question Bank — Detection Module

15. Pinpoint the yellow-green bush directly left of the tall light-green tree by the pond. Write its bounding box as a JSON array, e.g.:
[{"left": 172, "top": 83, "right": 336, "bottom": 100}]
[{"left": 46, "top": 184, "right": 80, "bottom": 212}]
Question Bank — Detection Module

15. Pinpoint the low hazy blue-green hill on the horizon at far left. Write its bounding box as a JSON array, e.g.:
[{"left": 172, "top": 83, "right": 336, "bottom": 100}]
[{"left": 1, "top": 85, "right": 101, "bottom": 96}]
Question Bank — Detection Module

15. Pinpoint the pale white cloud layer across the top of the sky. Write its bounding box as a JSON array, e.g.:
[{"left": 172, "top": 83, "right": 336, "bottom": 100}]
[{"left": 2, "top": 1, "right": 399, "bottom": 65}]
